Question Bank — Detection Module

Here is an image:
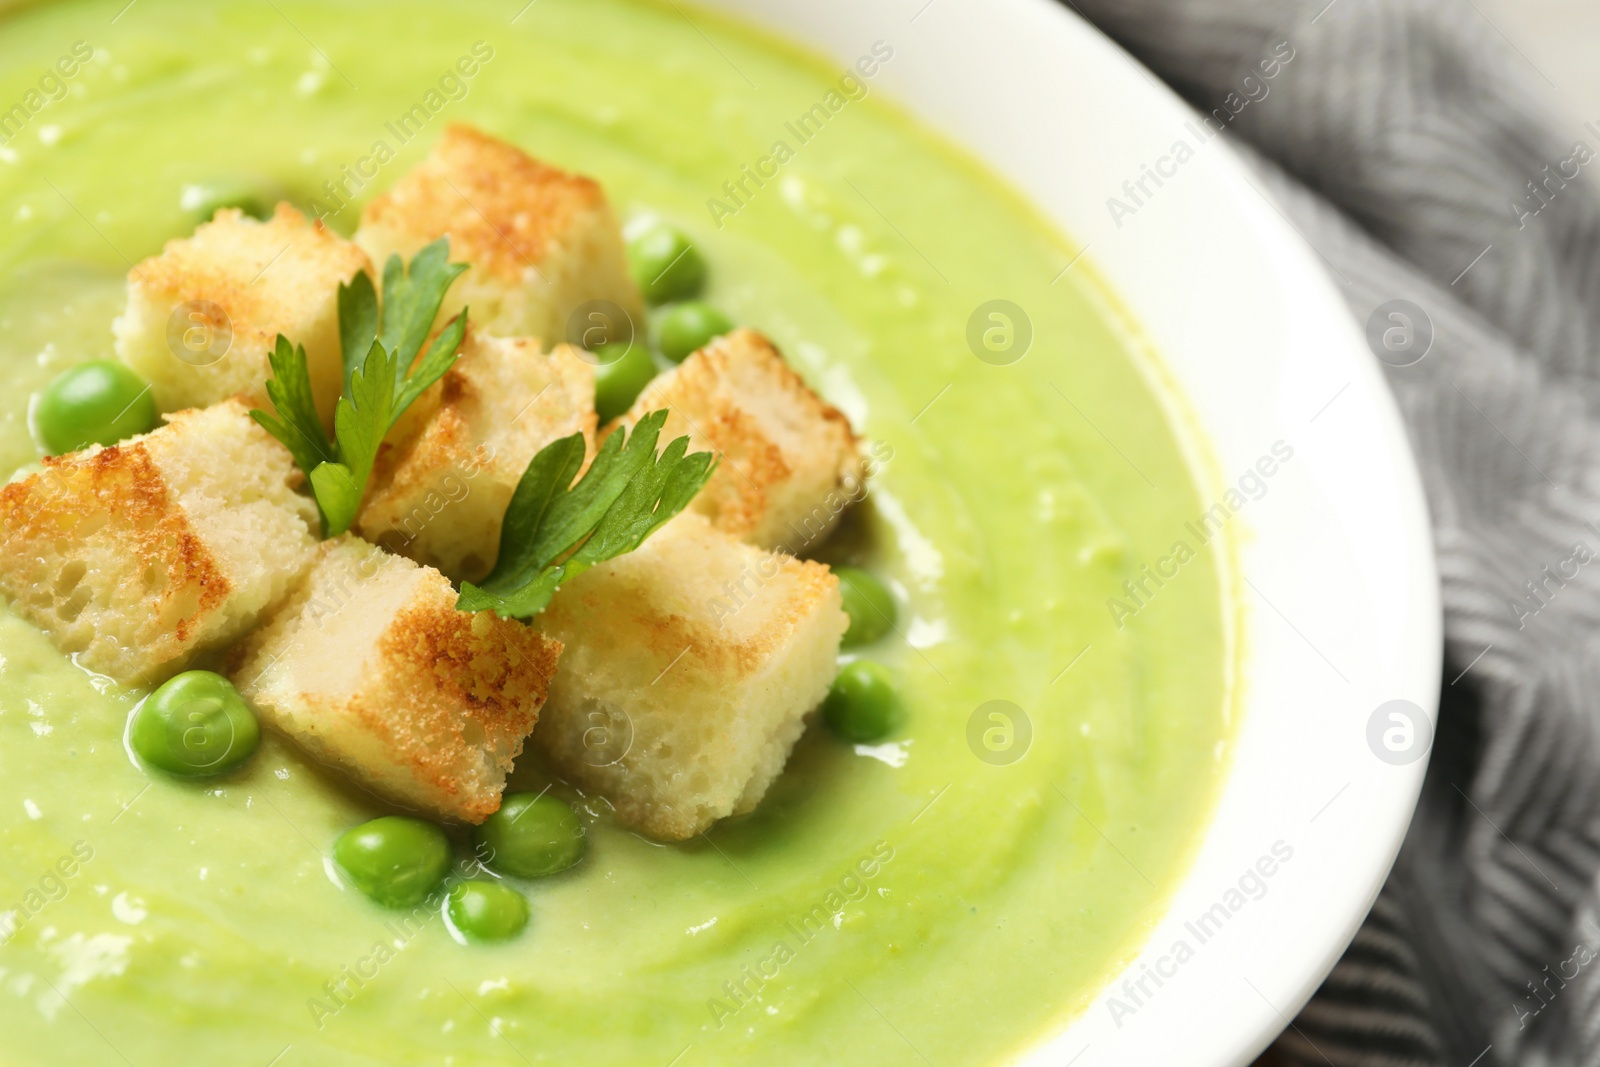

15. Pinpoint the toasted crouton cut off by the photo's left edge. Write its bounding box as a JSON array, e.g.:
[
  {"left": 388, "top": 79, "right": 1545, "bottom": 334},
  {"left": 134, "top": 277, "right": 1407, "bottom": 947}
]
[{"left": 0, "top": 400, "right": 317, "bottom": 685}]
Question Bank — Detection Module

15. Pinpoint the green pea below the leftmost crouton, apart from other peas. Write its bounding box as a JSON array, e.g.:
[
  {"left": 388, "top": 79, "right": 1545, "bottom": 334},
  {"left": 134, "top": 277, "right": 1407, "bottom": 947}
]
[{"left": 128, "top": 670, "right": 261, "bottom": 777}]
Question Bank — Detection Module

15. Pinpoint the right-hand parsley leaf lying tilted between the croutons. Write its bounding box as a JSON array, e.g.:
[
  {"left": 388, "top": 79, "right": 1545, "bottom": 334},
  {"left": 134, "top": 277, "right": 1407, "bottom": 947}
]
[{"left": 456, "top": 411, "right": 715, "bottom": 619}]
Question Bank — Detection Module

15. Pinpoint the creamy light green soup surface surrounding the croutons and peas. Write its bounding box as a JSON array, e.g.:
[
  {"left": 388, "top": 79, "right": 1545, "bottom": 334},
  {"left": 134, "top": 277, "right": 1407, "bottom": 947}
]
[{"left": 0, "top": 0, "right": 1232, "bottom": 1067}]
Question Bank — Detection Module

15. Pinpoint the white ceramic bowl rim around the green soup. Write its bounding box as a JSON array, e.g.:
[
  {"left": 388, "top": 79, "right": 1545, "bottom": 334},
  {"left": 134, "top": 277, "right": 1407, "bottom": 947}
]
[{"left": 712, "top": 0, "right": 1440, "bottom": 1067}]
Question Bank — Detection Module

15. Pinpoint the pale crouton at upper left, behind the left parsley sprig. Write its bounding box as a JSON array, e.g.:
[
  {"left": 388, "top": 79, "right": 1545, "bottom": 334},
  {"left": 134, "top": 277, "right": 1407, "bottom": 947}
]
[{"left": 114, "top": 203, "right": 371, "bottom": 426}]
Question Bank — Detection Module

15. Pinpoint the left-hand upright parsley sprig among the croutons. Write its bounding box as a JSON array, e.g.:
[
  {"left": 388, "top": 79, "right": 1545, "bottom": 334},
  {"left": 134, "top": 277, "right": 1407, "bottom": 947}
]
[{"left": 251, "top": 237, "right": 467, "bottom": 537}]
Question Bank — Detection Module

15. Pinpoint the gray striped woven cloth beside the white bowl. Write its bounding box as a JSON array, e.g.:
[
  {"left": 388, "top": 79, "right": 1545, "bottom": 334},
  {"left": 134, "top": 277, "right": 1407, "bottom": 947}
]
[{"left": 1056, "top": 0, "right": 1600, "bottom": 1067}]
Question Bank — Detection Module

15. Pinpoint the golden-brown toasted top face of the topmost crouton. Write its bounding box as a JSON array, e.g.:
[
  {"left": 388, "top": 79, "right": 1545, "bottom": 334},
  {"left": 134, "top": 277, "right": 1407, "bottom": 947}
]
[{"left": 362, "top": 123, "right": 605, "bottom": 280}]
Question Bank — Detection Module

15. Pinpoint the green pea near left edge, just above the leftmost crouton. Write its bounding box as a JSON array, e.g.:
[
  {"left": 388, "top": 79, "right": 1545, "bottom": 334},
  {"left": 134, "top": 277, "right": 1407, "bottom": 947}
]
[{"left": 34, "top": 360, "right": 160, "bottom": 456}]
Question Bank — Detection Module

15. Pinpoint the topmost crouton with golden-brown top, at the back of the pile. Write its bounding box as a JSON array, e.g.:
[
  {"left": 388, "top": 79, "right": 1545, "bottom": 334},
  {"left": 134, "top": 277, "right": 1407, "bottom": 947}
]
[{"left": 355, "top": 125, "right": 645, "bottom": 349}]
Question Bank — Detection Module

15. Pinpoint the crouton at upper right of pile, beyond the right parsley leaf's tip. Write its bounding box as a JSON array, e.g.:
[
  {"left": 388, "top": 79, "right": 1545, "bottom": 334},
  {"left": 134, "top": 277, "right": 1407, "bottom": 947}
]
[{"left": 606, "top": 330, "right": 866, "bottom": 553}]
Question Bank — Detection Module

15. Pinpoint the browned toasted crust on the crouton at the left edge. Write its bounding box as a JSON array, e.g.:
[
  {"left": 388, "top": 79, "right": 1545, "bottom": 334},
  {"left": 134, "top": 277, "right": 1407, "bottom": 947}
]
[{"left": 0, "top": 442, "right": 232, "bottom": 667}]
